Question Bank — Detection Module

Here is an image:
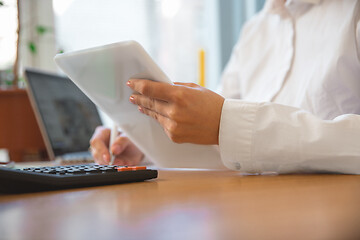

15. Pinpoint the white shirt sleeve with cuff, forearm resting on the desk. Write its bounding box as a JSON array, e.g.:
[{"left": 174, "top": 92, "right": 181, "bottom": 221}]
[{"left": 219, "top": 99, "right": 360, "bottom": 174}]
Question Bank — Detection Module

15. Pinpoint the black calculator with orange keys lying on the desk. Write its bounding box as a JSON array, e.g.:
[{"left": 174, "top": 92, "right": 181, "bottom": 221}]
[{"left": 0, "top": 164, "right": 158, "bottom": 193}]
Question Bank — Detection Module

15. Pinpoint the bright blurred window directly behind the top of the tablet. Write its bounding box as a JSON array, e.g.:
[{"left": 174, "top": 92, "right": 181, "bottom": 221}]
[{"left": 53, "top": 0, "right": 220, "bottom": 87}]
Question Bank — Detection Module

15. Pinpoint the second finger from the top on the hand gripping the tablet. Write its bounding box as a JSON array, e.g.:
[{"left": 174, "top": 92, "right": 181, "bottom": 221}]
[{"left": 130, "top": 94, "right": 168, "bottom": 117}]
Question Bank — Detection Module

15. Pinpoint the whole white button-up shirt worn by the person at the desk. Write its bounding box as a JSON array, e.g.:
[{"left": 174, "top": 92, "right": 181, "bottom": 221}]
[{"left": 219, "top": 0, "right": 360, "bottom": 174}]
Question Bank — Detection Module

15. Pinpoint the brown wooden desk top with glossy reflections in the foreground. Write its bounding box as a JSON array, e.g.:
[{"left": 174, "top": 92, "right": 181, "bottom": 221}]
[{"left": 0, "top": 170, "right": 360, "bottom": 240}]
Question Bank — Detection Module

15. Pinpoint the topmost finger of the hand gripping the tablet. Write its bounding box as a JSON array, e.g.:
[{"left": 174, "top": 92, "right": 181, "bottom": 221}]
[{"left": 126, "top": 79, "right": 175, "bottom": 101}]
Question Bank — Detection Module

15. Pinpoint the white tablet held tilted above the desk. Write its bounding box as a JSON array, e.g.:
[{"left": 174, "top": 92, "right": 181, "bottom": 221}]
[{"left": 54, "top": 41, "right": 225, "bottom": 169}]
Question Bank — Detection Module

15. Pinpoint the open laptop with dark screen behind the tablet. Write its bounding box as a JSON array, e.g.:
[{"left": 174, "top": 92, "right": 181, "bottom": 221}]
[{"left": 25, "top": 69, "right": 102, "bottom": 164}]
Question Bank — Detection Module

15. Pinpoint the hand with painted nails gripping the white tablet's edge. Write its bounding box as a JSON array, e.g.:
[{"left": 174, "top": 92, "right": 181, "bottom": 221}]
[{"left": 127, "top": 79, "right": 224, "bottom": 144}]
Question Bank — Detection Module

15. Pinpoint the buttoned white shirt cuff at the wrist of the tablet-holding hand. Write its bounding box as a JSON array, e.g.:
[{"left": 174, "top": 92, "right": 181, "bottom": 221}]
[{"left": 219, "top": 99, "right": 260, "bottom": 173}]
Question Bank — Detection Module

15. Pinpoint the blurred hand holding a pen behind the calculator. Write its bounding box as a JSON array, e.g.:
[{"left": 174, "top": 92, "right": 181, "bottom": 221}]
[{"left": 90, "top": 126, "right": 144, "bottom": 166}]
